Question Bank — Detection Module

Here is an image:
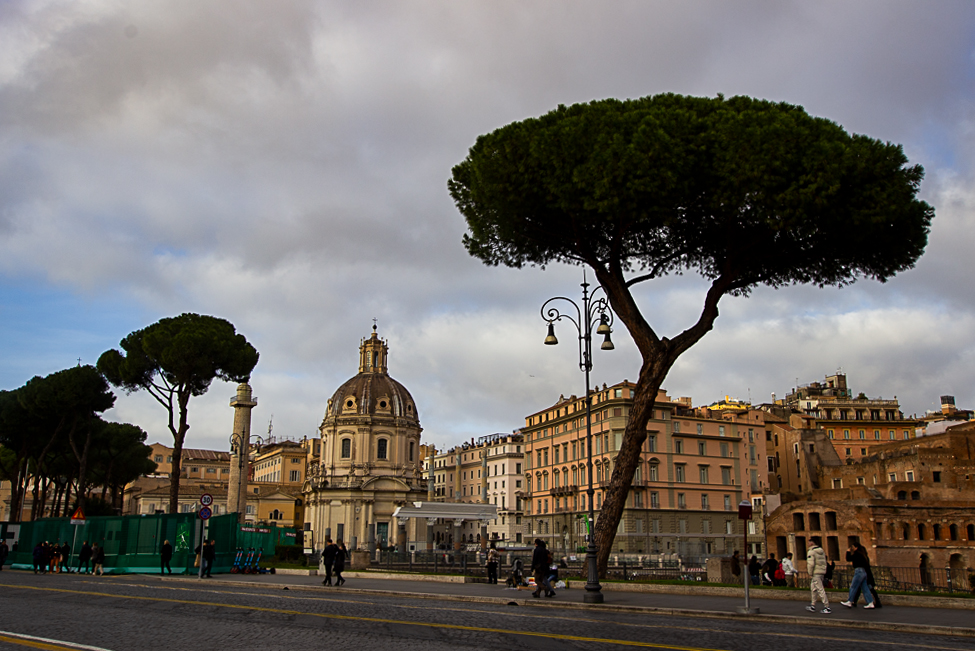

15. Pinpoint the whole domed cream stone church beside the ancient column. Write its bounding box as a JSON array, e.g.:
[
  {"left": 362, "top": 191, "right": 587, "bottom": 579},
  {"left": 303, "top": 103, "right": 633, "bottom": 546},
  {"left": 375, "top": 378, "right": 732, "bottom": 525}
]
[{"left": 302, "top": 326, "right": 427, "bottom": 551}]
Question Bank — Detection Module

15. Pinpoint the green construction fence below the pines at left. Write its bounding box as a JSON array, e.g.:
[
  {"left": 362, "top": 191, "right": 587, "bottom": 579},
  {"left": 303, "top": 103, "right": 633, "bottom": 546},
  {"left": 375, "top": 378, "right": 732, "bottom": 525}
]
[{"left": 7, "top": 513, "right": 295, "bottom": 574}]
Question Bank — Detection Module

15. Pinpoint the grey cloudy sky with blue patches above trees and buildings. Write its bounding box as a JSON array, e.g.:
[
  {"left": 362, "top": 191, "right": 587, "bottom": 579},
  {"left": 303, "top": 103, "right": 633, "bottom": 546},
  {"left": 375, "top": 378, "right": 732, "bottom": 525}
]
[{"left": 0, "top": 0, "right": 975, "bottom": 458}]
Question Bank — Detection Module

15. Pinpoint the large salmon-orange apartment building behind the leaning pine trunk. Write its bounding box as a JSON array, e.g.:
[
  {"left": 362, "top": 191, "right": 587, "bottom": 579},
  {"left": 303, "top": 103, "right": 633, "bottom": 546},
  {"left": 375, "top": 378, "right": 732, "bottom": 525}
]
[{"left": 522, "top": 380, "right": 767, "bottom": 557}]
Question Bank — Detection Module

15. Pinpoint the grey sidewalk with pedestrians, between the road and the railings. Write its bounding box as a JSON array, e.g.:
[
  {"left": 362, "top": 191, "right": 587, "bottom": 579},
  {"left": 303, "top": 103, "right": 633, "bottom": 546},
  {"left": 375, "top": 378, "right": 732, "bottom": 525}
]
[{"left": 154, "top": 572, "right": 975, "bottom": 638}]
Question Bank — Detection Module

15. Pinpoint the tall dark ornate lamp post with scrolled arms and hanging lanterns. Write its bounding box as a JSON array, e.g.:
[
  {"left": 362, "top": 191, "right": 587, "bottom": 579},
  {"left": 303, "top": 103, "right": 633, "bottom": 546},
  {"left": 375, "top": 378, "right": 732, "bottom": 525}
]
[{"left": 542, "top": 275, "right": 614, "bottom": 604}]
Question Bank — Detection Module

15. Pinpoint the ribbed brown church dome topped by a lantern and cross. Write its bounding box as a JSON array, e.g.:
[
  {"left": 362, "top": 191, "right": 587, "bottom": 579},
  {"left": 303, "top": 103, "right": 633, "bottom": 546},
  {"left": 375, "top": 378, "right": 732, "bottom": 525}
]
[{"left": 325, "top": 326, "right": 420, "bottom": 425}]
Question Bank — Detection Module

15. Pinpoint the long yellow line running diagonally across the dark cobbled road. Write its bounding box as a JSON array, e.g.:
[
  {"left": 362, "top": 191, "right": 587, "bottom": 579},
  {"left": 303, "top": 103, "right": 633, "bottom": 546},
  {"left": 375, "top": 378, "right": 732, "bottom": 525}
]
[{"left": 3, "top": 584, "right": 720, "bottom": 651}]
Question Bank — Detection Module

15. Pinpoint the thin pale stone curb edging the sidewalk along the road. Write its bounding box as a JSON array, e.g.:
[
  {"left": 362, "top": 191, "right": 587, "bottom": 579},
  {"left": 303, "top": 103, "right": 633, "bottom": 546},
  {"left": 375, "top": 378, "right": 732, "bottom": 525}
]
[{"left": 154, "top": 577, "right": 975, "bottom": 638}]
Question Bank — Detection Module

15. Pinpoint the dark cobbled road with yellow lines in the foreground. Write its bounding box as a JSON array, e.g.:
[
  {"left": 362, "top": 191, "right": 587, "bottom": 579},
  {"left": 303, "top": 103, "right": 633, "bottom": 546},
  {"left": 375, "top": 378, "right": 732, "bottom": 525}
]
[{"left": 0, "top": 571, "right": 973, "bottom": 651}]
